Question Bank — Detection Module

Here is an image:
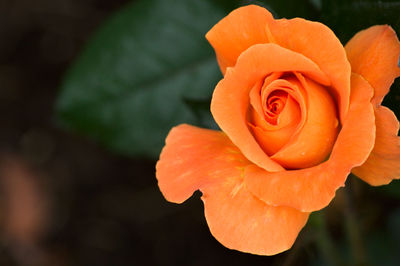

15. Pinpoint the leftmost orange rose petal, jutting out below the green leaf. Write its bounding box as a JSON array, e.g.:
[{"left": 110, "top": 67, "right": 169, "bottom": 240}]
[{"left": 156, "top": 124, "right": 248, "bottom": 203}]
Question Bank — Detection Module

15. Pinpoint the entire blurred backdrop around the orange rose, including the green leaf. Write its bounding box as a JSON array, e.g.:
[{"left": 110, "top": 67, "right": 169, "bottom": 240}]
[{"left": 0, "top": 0, "right": 400, "bottom": 266}]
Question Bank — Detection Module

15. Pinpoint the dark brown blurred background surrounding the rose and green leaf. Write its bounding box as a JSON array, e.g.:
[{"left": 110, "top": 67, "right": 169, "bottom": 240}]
[{"left": 0, "top": 0, "right": 400, "bottom": 266}]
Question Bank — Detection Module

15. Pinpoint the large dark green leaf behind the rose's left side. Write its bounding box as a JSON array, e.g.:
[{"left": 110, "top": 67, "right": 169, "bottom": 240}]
[{"left": 56, "top": 0, "right": 233, "bottom": 158}]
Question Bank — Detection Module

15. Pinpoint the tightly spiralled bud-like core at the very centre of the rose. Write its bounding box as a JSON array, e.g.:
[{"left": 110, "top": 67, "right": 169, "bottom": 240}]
[{"left": 249, "top": 73, "right": 306, "bottom": 156}]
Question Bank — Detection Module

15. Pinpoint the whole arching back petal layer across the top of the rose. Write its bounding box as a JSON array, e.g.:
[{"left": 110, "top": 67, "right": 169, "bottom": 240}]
[{"left": 206, "top": 5, "right": 351, "bottom": 121}]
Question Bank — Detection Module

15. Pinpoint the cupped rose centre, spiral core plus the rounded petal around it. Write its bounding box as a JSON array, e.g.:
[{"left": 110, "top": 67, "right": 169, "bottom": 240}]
[{"left": 249, "top": 73, "right": 339, "bottom": 169}]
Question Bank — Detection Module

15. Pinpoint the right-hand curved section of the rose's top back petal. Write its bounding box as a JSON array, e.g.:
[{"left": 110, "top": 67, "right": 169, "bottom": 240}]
[{"left": 270, "top": 15, "right": 351, "bottom": 123}]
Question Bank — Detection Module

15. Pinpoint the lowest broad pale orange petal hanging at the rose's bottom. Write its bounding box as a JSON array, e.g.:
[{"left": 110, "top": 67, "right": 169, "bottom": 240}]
[{"left": 202, "top": 175, "right": 309, "bottom": 255}]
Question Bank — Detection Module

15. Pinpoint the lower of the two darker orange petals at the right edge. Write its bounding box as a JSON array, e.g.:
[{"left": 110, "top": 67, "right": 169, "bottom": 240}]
[{"left": 352, "top": 106, "right": 400, "bottom": 186}]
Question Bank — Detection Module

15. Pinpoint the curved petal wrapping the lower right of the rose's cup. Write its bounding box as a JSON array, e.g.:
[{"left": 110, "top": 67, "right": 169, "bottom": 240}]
[{"left": 245, "top": 75, "right": 375, "bottom": 212}]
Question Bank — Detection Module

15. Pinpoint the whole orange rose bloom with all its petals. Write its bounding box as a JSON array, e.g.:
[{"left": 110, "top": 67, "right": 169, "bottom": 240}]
[{"left": 156, "top": 5, "right": 400, "bottom": 255}]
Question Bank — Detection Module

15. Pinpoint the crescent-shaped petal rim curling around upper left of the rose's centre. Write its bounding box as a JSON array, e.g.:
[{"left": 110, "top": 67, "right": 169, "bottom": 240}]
[{"left": 211, "top": 44, "right": 329, "bottom": 171}]
